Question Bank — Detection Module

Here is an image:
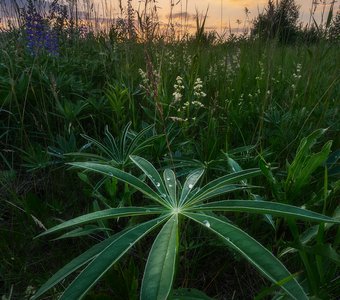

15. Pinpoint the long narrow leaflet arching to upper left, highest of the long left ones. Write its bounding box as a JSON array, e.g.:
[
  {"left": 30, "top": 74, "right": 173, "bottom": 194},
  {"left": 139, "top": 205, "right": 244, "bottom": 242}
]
[{"left": 69, "top": 162, "right": 171, "bottom": 208}]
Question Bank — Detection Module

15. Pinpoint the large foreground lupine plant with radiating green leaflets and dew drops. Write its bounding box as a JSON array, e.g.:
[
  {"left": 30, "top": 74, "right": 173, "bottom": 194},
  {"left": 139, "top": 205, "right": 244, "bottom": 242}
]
[{"left": 32, "top": 156, "right": 338, "bottom": 300}]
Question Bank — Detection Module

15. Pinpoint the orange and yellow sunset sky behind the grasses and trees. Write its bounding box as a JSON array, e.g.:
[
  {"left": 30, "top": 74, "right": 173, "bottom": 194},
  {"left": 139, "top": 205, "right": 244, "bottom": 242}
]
[{"left": 0, "top": 0, "right": 339, "bottom": 31}]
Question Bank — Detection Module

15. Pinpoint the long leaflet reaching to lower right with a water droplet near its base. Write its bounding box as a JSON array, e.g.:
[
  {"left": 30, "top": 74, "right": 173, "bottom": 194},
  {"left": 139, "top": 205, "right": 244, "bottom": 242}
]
[{"left": 184, "top": 212, "right": 308, "bottom": 300}]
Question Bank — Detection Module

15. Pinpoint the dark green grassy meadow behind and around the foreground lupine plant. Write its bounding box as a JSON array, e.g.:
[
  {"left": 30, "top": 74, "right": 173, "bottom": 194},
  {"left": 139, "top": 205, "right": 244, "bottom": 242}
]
[{"left": 0, "top": 1, "right": 340, "bottom": 299}]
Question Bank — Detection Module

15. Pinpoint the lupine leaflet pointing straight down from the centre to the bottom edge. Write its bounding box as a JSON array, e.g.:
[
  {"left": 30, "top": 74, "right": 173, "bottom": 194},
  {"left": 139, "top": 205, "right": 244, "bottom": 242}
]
[{"left": 140, "top": 214, "right": 178, "bottom": 300}]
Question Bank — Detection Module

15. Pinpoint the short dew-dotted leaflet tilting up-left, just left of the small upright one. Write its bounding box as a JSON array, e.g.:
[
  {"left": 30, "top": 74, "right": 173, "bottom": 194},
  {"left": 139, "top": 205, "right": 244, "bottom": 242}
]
[{"left": 130, "top": 155, "right": 171, "bottom": 202}]
